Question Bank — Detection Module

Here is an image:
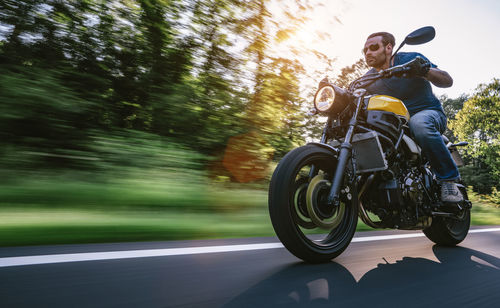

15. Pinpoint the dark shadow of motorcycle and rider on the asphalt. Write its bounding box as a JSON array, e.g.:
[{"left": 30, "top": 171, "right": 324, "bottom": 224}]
[{"left": 223, "top": 245, "right": 500, "bottom": 308}]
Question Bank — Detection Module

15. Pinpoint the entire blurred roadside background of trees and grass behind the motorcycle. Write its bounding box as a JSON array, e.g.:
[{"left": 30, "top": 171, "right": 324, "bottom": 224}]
[{"left": 0, "top": 0, "right": 500, "bottom": 246}]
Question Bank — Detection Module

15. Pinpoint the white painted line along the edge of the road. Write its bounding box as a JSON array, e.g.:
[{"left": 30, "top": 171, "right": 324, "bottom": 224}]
[{"left": 0, "top": 228, "right": 500, "bottom": 267}]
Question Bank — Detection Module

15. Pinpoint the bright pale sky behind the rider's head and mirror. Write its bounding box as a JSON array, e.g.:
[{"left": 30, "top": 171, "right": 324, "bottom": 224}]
[{"left": 280, "top": 0, "right": 500, "bottom": 98}]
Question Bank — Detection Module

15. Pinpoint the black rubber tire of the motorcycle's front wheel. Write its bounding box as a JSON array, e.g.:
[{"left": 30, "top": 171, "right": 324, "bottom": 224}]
[{"left": 269, "top": 145, "right": 358, "bottom": 263}]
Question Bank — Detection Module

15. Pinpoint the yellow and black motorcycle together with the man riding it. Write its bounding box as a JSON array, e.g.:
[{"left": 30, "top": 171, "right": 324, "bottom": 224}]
[{"left": 268, "top": 26, "right": 472, "bottom": 263}]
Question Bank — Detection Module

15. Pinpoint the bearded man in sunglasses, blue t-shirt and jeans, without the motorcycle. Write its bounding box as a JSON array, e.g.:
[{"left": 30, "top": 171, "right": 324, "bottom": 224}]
[{"left": 363, "top": 32, "right": 463, "bottom": 203}]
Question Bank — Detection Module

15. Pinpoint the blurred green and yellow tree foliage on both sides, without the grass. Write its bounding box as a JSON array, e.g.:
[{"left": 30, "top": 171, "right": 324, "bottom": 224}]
[{"left": 0, "top": 0, "right": 500, "bottom": 190}]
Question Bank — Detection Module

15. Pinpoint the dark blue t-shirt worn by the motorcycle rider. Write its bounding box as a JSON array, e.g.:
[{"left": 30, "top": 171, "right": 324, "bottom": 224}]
[{"left": 366, "top": 52, "right": 443, "bottom": 116}]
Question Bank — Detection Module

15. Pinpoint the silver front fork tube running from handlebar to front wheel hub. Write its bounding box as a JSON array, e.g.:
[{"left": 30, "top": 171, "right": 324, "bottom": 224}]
[{"left": 327, "top": 95, "right": 363, "bottom": 206}]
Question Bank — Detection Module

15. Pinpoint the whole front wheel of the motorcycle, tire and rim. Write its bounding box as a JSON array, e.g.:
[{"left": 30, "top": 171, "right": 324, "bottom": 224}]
[{"left": 269, "top": 145, "right": 358, "bottom": 263}]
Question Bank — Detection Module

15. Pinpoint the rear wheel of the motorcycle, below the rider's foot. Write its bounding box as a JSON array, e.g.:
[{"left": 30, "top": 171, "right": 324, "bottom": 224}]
[{"left": 424, "top": 188, "right": 470, "bottom": 246}]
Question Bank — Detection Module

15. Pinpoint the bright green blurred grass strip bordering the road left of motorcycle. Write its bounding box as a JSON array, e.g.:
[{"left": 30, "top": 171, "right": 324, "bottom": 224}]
[{"left": 0, "top": 208, "right": 272, "bottom": 246}]
